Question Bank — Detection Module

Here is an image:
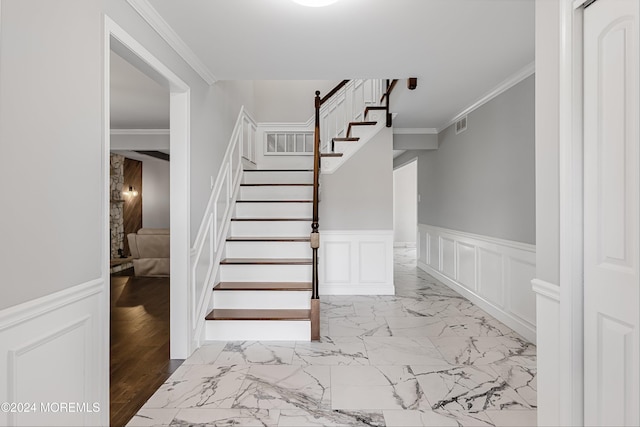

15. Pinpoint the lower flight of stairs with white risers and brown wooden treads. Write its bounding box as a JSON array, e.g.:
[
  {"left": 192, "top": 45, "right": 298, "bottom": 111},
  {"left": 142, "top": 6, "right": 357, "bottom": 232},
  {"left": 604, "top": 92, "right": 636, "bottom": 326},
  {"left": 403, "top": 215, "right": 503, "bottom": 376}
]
[{"left": 205, "top": 170, "right": 313, "bottom": 341}]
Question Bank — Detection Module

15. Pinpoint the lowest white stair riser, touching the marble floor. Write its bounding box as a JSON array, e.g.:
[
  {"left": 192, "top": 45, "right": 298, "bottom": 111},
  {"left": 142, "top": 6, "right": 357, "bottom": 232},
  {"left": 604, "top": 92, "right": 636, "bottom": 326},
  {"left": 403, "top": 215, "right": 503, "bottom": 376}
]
[{"left": 205, "top": 320, "right": 311, "bottom": 341}]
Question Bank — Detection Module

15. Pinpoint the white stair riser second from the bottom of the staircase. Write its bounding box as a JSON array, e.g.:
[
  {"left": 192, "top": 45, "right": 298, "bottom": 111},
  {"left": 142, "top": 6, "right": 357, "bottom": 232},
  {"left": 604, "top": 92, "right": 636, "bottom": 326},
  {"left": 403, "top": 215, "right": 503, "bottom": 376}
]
[{"left": 213, "top": 291, "right": 311, "bottom": 310}]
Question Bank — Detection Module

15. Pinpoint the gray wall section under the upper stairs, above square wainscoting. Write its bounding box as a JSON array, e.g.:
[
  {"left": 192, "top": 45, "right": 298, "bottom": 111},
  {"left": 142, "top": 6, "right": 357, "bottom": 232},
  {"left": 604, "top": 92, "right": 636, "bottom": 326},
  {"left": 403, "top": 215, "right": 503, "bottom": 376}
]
[{"left": 319, "top": 128, "right": 393, "bottom": 230}]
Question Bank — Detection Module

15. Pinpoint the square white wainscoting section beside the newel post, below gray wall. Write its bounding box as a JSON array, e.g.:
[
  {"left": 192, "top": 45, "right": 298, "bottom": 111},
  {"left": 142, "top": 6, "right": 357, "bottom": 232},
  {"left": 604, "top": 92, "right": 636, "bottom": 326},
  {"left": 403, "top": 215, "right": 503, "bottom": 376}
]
[{"left": 318, "top": 230, "right": 395, "bottom": 295}]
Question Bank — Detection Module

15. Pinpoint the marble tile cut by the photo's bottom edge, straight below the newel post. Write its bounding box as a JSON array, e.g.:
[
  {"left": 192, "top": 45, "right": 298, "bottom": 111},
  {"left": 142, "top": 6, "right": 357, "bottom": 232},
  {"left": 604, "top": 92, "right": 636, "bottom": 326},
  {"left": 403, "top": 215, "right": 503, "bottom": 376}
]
[{"left": 278, "top": 408, "right": 385, "bottom": 427}]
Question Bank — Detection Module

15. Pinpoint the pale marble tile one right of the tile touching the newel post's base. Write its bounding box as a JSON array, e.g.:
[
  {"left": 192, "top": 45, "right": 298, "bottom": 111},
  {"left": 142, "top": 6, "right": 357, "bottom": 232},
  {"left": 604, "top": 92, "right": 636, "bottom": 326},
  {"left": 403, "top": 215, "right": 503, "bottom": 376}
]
[{"left": 364, "top": 337, "right": 446, "bottom": 365}]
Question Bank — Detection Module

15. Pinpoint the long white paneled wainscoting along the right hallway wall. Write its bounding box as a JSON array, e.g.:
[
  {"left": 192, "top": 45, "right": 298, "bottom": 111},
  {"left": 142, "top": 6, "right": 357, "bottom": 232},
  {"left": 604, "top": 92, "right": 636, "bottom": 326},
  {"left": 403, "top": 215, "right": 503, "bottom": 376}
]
[{"left": 417, "top": 224, "right": 536, "bottom": 343}]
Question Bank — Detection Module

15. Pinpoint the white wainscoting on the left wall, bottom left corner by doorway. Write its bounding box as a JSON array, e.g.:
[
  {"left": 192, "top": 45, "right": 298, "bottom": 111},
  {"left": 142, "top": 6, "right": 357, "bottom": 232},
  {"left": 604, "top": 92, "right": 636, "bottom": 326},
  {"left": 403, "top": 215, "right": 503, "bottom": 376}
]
[{"left": 0, "top": 279, "right": 109, "bottom": 426}]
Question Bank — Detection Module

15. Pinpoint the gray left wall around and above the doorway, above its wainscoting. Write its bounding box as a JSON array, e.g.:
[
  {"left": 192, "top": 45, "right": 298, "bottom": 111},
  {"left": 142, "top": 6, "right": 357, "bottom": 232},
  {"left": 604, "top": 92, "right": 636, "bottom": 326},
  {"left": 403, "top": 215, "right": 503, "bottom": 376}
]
[{"left": 0, "top": 0, "right": 253, "bottom": 309}]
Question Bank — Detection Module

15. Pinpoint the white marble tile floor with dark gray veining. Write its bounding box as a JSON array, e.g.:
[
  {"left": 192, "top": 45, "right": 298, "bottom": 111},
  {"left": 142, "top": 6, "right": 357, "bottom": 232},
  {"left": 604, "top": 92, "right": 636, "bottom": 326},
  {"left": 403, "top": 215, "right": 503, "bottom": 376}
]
[{"left": 128, "top": 248, "right": 536, "bottom": 426}]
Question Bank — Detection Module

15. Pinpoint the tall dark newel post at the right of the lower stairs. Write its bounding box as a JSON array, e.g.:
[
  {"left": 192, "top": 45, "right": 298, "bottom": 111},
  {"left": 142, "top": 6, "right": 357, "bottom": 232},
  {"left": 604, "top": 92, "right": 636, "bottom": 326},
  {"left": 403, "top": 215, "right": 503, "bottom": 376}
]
[{"left": 310, "top": 91, "right": 322, "bottom": 341}]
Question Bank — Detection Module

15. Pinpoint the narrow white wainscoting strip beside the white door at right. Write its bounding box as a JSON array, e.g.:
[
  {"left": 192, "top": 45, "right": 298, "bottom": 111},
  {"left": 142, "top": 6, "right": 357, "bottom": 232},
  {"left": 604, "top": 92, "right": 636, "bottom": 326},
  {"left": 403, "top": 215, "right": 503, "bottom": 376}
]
[{"left": 531, "top": 279, "right": 560, "bottom": 426}]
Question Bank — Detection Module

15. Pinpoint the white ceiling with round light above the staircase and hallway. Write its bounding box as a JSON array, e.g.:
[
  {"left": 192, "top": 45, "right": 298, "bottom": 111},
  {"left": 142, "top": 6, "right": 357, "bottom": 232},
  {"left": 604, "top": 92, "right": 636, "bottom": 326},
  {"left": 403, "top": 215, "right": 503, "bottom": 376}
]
[{"left": 148, "top": 0, "right": 534, "bottom": 128}]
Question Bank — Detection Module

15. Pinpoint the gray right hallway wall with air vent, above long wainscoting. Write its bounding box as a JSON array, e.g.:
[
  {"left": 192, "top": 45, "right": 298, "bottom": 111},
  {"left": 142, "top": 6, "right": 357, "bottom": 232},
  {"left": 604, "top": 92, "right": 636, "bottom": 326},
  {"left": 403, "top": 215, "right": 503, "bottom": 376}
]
[{"left": 395, "top": 76, "right": 536, "bottom": 244}]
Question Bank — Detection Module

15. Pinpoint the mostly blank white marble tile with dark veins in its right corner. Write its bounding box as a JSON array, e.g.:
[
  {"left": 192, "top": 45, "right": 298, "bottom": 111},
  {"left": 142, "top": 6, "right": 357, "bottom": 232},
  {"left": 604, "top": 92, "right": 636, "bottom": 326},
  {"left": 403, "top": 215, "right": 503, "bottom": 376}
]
[{"left": 331, "top": 366, "right": 428, "bottom": 410}]
